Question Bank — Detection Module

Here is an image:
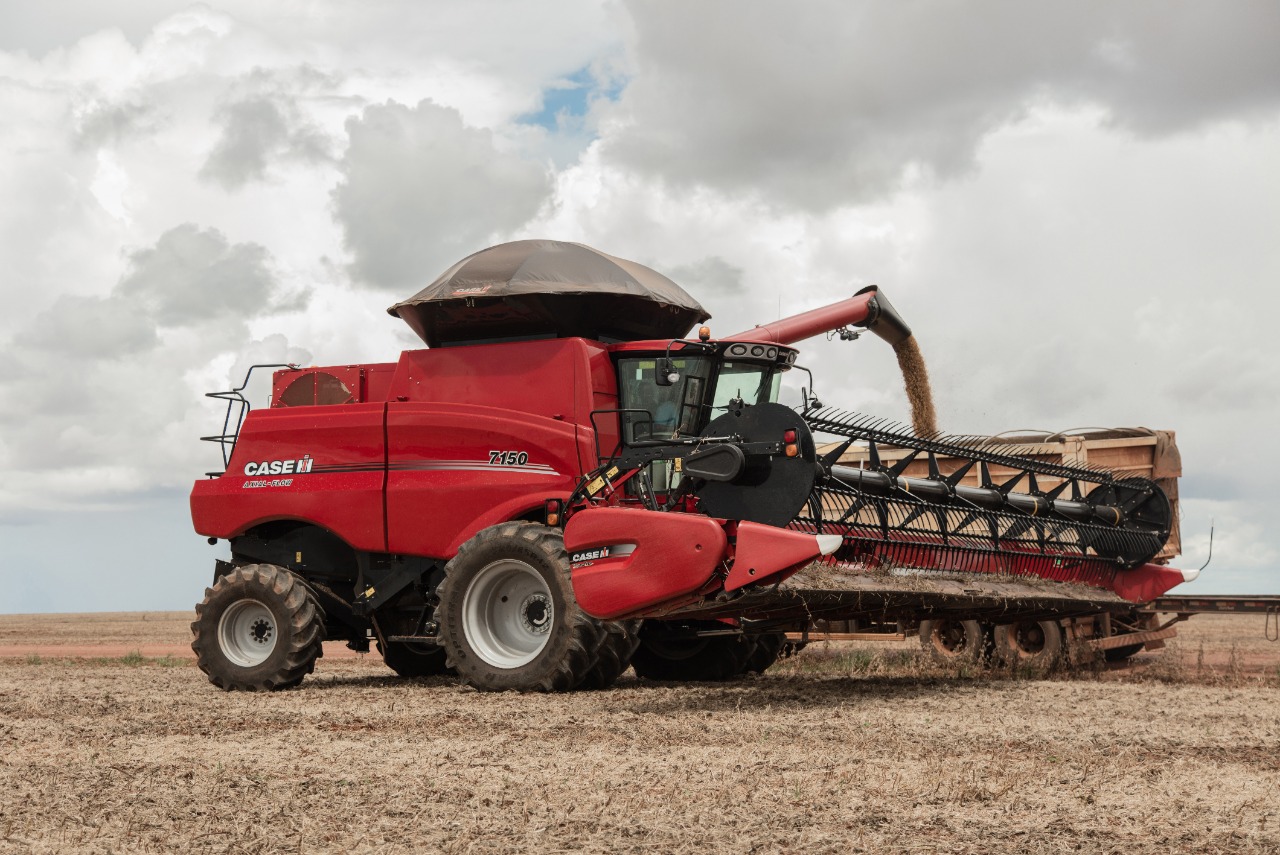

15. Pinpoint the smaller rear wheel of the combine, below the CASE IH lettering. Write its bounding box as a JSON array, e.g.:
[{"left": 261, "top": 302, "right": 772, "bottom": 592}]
[{"left": 191, "top": 564, "right": 324, "bottom": 691}]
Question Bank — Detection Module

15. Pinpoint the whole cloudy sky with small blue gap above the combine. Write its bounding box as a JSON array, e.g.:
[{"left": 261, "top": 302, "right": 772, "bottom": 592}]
[{"left": 0, "top": 0, "right": 1280, "bottom": 612}]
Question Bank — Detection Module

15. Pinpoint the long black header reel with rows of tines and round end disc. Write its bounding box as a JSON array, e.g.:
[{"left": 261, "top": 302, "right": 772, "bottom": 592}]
[{"left": 575, "top": 402, "right": 1172, "bottom": 593}]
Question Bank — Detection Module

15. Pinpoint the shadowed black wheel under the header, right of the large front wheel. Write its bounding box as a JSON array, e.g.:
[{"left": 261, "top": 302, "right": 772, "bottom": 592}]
[{"left": 631, "top": 621, "right": 756, "bottom": 682}]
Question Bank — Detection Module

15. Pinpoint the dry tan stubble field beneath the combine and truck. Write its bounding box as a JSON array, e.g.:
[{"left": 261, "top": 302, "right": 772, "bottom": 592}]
[{"left": 0, "top": 613, "right": 1280, "bottom": 854}]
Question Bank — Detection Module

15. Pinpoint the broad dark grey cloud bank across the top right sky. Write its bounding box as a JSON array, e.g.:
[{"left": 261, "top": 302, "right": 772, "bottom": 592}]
[{"left": 607, "top": 0, "right": 1280, "bottom": 210}]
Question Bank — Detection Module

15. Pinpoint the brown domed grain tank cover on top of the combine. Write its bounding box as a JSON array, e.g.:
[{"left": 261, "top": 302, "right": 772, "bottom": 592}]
[{"left": 387, "top": 241, "right": 710, "bottom": 347}]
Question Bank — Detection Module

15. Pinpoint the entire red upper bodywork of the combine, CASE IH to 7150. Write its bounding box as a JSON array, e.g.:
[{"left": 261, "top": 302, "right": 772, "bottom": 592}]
[{"left": 191, "top": 339, "right": 618, "bottom": 558}]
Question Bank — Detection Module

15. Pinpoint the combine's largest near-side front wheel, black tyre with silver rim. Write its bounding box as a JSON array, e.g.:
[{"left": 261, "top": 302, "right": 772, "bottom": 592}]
[{"left": 436, "top": 521, "right": 605, "bottom": 691}]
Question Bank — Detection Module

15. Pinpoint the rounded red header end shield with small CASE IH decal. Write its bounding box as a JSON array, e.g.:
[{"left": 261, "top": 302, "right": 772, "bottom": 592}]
[{"left": 564, "top": 508, "right": 728, "bottom": 619}]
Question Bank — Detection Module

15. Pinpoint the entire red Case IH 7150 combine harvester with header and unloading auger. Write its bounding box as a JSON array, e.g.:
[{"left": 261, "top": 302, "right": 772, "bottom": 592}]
[{"left": 191, "top": 241, "right": 1194, "bottom": 691}]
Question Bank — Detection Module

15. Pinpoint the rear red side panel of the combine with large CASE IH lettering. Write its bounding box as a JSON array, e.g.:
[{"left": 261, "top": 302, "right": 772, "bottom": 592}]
[{"left": 191, "top": 403, "right": 387, "bottom": 552}]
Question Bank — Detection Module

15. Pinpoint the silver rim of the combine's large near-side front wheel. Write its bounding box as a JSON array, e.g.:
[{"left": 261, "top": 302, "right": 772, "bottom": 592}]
[{"left": 462, "top": 559, "right": 556, "bottom": 668}]
